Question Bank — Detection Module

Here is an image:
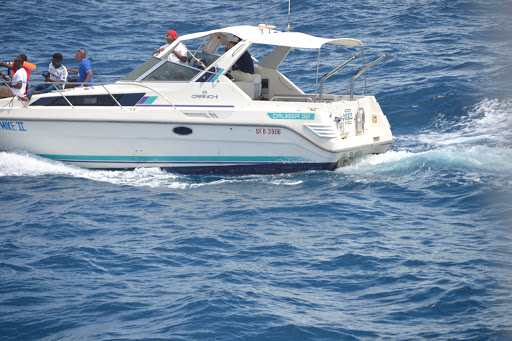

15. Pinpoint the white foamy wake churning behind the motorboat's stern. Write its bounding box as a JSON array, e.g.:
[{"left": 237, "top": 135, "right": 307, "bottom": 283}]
[{"left": 339, "top": 95, "right": 512, "bottom": 184}]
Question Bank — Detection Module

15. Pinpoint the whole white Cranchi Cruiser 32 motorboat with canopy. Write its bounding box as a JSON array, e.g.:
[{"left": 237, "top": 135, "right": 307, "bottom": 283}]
[{"left": 0, "top": 24, "right": 393, "bottom": 173}]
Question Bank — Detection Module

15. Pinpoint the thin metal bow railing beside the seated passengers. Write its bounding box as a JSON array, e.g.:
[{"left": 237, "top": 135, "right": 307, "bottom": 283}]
[{"left": 0, "top": 76, "right": 176, "bottom": 109}]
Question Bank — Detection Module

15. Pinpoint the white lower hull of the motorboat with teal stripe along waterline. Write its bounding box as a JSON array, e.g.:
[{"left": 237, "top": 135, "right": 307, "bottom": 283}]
[{"left": 0, "top": 116, "right": 391, "bottom": 174}]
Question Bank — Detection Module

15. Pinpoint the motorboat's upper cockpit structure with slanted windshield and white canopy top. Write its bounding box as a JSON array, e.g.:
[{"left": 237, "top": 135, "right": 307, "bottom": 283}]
[{"left": 121, "top": 24, "right": 370, "bottom": 102}]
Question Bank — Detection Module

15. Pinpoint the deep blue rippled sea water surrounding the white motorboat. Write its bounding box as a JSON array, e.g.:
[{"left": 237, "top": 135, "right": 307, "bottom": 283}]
[{"left": 0, "top": 0, "right": 512, "bottom": 340}]
